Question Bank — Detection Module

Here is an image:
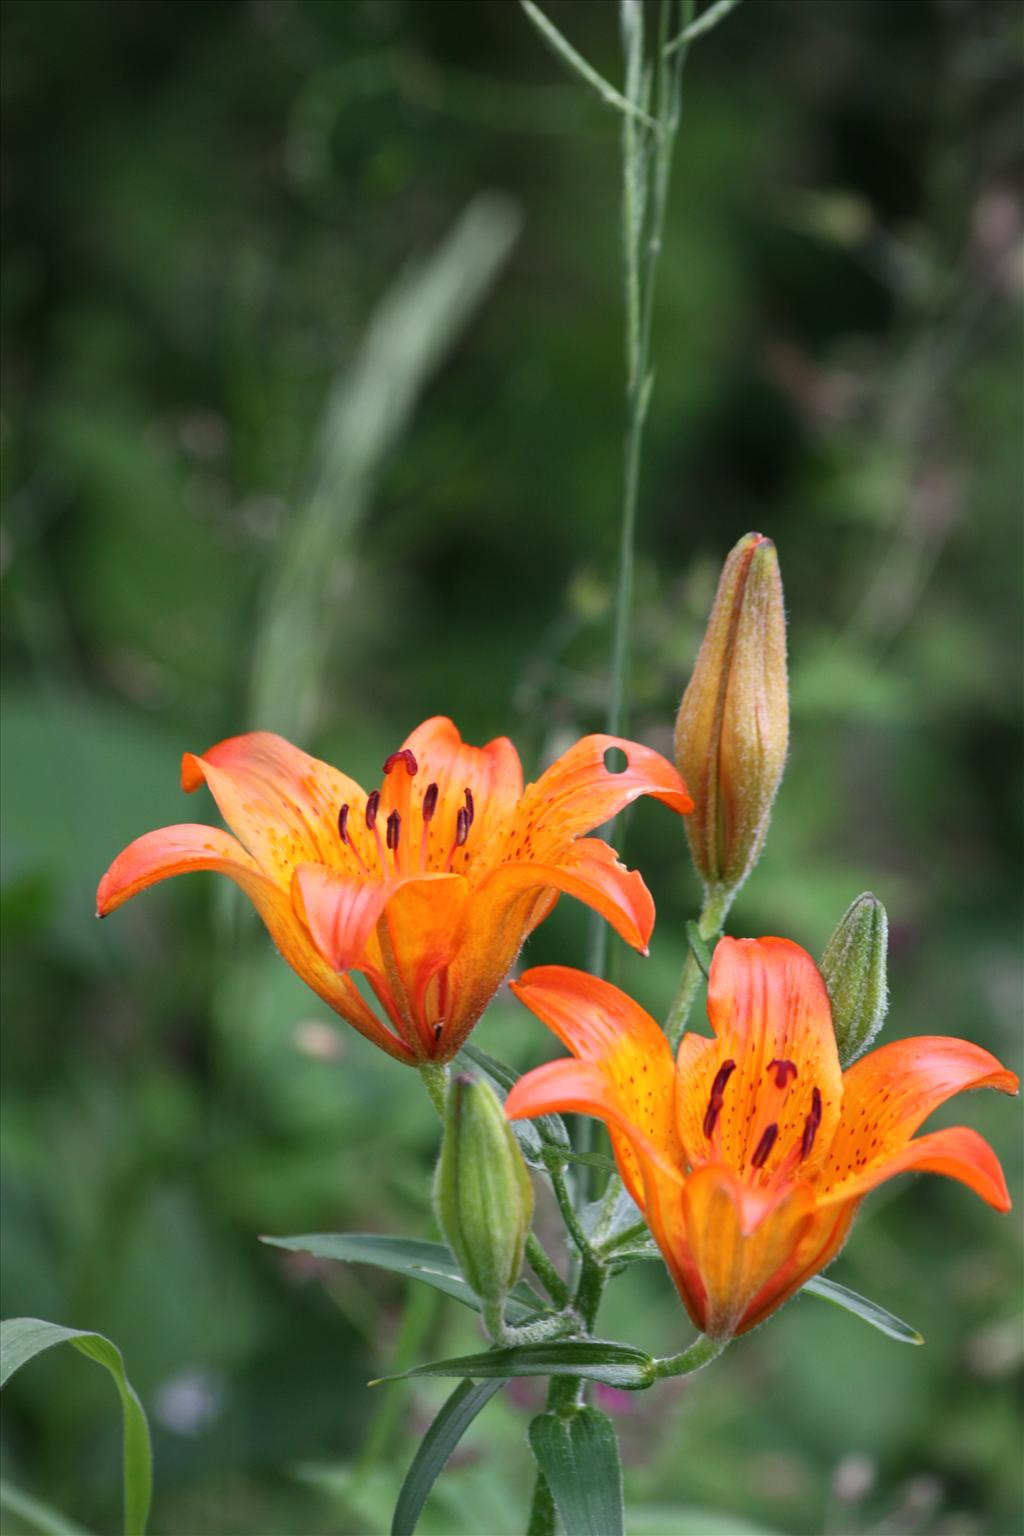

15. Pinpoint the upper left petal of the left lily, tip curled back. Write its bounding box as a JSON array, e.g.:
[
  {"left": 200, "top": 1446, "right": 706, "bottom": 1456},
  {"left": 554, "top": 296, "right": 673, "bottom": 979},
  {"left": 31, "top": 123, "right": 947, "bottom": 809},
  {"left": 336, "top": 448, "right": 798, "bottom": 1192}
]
[{"left": 181, "top": 731, "right": 367, "bottom": 886}]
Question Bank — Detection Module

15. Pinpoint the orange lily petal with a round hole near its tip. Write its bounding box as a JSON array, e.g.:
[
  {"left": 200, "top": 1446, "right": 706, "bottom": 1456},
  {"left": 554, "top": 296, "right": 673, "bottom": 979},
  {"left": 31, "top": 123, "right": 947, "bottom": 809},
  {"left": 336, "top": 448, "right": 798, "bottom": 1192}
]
[{"left": 508, "top": 736, "right": 694, "bottom": 860}]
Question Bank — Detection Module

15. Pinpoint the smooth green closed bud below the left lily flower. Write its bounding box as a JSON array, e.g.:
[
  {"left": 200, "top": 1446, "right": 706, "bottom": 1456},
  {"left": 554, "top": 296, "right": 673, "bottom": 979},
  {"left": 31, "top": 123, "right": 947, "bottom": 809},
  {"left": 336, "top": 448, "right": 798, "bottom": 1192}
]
[{"left": 434, "top": 1074, "right": 533, "bottom": 1326}]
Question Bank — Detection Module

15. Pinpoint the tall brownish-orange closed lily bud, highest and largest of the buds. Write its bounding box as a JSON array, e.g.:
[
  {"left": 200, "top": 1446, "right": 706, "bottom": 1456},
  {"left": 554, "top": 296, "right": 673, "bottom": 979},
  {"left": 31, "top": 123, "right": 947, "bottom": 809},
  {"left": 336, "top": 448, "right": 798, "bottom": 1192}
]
[{"left": 676, "top": 533, "right": 789, "bottom": 905}]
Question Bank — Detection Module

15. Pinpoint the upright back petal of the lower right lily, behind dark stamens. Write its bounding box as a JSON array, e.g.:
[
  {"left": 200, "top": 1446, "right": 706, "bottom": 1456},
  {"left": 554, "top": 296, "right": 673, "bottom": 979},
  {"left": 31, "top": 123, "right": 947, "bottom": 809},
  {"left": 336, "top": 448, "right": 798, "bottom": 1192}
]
[{"left": 677, "top": 938, "right": 843, "bottom": 1177}]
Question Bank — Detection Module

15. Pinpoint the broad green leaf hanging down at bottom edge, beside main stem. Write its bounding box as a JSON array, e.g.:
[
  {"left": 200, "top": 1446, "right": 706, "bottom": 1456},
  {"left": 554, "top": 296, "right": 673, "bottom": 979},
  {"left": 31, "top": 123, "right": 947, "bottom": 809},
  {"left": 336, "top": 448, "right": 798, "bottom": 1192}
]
[{"left": 530, "top": 1407, "right": 623, "bottom": 1536}]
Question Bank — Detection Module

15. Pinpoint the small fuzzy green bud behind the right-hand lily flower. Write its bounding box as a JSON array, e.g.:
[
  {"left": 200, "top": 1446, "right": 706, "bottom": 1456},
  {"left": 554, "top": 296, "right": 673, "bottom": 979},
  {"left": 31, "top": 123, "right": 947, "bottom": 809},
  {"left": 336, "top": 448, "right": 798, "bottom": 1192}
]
[{"left": 820, "top": 891, "right": 889, "bottom": 1068}]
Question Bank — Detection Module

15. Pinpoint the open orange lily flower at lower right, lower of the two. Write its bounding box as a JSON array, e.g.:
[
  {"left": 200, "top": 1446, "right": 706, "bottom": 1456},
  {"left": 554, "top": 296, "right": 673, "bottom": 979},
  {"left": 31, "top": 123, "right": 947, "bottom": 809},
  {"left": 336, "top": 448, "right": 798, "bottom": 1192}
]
[{"left": 505, "top": 938, "right": 1018, "bottom": 1338}]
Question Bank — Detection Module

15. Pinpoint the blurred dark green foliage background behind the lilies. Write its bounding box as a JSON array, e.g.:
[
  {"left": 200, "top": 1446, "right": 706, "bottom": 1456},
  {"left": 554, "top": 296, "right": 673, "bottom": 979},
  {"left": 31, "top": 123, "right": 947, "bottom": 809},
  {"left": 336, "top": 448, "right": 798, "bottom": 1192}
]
[{"left": 2, "top": 0, "right": 1024, "bottom": 1536}]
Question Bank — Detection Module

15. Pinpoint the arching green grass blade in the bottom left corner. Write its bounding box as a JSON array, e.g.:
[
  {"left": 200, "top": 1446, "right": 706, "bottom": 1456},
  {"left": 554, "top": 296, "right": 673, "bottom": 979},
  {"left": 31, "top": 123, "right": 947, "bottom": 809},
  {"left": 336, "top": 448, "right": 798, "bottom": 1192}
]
[{"left": 0, "top": 1318, "right": 154, "bottom": 1536}]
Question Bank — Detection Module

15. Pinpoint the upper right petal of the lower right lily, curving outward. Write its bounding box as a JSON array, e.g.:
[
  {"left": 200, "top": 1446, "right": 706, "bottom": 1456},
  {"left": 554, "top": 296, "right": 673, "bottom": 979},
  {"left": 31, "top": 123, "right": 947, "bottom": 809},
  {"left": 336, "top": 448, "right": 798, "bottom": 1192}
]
[{"left": 821, "top": 1035, "right": 1018, "bottom": 1209}]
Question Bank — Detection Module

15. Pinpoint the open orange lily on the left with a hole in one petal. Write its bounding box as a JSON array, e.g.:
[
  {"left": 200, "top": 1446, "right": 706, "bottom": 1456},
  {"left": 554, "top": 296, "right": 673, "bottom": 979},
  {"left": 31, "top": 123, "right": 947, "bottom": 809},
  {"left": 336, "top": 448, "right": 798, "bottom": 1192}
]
[{"left": 97, "top": 716, "right": 692, "bottom": 1064}]
